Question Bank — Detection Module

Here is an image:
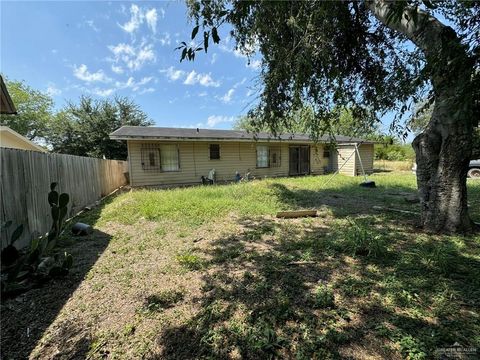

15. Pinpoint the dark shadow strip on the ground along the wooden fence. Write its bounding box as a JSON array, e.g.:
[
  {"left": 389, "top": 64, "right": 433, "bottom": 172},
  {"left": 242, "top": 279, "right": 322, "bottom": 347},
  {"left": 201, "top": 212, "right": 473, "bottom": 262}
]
[{"left": 1, "top": 197, "right": 117, "bottom": 359}]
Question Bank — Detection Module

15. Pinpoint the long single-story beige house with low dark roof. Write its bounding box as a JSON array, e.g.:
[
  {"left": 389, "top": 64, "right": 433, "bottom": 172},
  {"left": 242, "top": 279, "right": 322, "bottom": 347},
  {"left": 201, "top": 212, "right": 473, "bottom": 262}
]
[{"left": 110, "top": 126, "right": 373, "bottom": 186}]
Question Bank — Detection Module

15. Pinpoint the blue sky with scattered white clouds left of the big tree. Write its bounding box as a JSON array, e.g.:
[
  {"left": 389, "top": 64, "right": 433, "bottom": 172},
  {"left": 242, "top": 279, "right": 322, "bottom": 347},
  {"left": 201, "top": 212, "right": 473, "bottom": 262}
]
[{"left": 0, "top": 1, "right": 260, "bottom": 129}]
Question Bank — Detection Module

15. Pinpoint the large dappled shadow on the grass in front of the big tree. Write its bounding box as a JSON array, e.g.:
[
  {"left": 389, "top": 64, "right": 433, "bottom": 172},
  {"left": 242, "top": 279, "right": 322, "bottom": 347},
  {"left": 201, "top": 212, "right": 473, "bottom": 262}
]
[{"left": 153, "top": 214, "right": 480, "bottom": 359}]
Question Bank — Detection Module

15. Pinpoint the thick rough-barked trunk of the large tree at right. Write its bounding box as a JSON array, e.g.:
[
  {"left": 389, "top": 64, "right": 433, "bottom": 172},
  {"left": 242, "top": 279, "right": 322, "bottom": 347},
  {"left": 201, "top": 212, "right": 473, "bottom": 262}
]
[{"left": 367, "top": 0, "right": 474, "bottom": 233}]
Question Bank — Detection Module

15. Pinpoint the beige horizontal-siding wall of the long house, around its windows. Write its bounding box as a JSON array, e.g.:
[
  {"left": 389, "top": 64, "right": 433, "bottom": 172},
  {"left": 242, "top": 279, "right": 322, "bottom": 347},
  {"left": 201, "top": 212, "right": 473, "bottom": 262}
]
[{"left": 128, "top": 140, "right": 328, "bottom": 186}]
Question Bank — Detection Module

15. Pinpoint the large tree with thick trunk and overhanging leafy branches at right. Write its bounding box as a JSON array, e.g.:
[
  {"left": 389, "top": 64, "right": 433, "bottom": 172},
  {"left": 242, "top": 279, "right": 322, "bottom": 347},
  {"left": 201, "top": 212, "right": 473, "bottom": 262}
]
[{"left": 180, "top": 0, "right": 480, "bottom": 232}]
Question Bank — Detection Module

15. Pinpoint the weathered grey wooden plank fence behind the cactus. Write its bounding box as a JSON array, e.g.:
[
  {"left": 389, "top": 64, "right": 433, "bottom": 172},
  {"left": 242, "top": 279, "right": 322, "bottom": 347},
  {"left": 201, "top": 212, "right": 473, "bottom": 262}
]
[{"left": 0, "top": 148, "right": 128, "bottom": 249}]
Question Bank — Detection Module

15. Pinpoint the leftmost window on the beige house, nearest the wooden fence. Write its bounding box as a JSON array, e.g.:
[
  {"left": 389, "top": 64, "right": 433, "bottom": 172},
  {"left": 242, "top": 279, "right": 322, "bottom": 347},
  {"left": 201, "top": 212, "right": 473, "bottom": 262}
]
[{"left": 141, "top": 144, "right": 180, "bottom": 171}]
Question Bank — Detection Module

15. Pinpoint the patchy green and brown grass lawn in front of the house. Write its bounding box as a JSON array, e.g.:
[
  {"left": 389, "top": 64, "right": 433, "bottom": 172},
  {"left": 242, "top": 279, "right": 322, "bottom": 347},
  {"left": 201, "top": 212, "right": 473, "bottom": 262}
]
[{"left": 1, "top": 171, "right": 480, "bottom": 359}]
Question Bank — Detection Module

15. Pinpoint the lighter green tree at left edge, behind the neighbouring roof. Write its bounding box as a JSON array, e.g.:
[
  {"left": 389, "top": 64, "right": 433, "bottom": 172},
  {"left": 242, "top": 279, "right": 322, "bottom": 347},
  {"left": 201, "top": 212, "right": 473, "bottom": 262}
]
[{"left": 0, "top": 79, "right": 53, "bottom": 140}]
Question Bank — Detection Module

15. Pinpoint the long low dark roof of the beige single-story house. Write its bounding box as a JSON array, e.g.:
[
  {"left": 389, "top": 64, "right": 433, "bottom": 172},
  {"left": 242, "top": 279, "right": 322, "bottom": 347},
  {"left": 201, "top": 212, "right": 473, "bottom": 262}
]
[{"left": 110, "top": 126, "right": 373, "bottom": 144}]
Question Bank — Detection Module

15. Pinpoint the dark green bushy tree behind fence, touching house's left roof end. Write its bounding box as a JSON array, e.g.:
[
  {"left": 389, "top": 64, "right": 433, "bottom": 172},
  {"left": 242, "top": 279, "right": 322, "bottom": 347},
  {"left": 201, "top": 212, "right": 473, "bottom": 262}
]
[{"left": 47, "top": 96, "right": 152, "bottom": 160}]
